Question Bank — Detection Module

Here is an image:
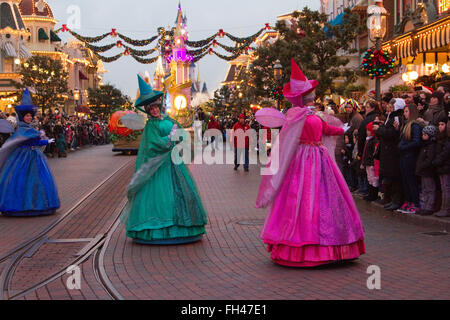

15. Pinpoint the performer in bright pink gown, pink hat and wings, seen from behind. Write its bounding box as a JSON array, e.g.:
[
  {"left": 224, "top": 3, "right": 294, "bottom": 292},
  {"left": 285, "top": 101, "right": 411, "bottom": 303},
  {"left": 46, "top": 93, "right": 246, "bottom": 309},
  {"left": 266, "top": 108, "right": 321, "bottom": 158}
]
[{"left": 256, "top": 59, "right": 365, "bottom": 267}]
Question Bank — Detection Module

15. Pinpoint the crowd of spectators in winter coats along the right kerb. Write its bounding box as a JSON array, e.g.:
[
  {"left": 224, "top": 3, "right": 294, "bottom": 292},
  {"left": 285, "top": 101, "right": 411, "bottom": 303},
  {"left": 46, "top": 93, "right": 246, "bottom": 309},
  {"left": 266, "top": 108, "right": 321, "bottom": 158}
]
[{"left": 333, "top": 86, "right": 450, "bottom": 217}]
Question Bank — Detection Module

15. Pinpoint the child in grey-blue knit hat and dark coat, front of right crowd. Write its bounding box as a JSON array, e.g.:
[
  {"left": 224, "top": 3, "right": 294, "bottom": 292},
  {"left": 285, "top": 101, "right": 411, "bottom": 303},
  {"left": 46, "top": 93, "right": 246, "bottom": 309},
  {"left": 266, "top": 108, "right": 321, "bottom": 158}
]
[{"left": 416, "top": 126, "right": 437, "bottom": 216}]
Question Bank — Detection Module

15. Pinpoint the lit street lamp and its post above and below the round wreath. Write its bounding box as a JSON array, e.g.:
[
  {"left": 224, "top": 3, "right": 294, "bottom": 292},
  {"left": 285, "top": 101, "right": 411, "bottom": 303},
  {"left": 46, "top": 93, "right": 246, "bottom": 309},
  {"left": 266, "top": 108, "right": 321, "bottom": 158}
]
[{"left": 367, "top": 0, "right": 388, "bottom": 101}]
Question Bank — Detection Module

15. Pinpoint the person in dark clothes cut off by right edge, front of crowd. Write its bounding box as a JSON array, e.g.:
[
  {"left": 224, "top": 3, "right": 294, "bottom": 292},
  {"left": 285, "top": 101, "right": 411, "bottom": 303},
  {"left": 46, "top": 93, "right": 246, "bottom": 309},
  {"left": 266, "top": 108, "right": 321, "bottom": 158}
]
[{"left": 433, "top": 115, "right": 450, "bottom": 217}]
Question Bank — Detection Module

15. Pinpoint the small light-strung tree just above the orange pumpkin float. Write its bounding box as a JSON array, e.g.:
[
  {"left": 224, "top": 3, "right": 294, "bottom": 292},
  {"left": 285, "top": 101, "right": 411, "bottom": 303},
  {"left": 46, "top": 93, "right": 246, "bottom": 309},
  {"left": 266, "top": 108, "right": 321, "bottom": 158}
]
[{"left": 88, "top": 84, "right": 131, "bottom": 116}]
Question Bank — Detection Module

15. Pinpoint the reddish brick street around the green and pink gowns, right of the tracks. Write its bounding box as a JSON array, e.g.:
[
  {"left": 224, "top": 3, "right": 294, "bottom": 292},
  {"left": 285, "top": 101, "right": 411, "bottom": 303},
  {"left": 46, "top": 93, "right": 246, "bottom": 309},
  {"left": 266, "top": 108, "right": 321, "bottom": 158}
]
[{"left": 100, "top": 165, "right": 450, "bottom": 300}]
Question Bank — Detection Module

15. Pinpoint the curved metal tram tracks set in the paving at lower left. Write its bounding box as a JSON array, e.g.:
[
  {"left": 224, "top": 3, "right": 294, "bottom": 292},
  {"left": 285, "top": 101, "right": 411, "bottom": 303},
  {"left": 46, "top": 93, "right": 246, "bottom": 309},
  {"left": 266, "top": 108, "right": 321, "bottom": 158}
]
[{"left": 0, "top": 159, "right": 134, "bottom": 300}]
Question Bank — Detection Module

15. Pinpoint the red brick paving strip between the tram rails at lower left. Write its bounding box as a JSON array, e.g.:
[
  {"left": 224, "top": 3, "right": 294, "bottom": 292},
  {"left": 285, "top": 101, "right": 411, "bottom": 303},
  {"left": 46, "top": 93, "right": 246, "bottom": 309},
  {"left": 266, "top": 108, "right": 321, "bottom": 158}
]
[{"left": 10, "top": 161, "right": 134, "bottom": 299}]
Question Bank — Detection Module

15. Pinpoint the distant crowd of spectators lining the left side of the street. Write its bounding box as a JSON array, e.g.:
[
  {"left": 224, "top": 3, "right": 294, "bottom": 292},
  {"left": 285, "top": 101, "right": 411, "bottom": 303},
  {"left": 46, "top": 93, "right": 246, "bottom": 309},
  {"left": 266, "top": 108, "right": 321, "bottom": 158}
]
[{"left": 0, "top": 109, "right": 110, "bottom": 158}]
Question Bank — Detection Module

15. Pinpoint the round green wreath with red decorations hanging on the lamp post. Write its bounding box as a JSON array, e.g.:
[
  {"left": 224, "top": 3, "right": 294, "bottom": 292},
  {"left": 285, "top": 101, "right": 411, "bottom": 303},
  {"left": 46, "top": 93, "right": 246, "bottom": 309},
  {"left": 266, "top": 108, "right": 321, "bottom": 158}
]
[{"left": 361, "top": 48, "right": 395, "bottom": 79}]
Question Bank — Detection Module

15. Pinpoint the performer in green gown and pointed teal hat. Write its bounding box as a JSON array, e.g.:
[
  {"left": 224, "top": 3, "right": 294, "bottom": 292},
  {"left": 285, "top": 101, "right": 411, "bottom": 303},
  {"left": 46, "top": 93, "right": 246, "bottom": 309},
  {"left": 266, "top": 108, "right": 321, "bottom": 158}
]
[{"left": 122, "top": 76, "right": 207, "bottom": 244}]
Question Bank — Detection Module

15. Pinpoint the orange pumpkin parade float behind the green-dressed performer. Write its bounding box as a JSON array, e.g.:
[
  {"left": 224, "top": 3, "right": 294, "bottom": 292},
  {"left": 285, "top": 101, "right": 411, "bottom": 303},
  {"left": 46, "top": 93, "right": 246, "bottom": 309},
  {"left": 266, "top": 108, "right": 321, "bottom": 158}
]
[{"left": 108, "top": 111, "right": 143, "bottom": 154}]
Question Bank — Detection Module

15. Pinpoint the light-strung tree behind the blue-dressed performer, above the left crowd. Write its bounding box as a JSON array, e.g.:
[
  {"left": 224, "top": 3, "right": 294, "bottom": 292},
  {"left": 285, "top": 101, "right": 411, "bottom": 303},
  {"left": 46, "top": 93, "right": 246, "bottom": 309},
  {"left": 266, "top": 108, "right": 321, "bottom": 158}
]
[{"left": 13, "top": 56, "right": 68, "bottom": 112}]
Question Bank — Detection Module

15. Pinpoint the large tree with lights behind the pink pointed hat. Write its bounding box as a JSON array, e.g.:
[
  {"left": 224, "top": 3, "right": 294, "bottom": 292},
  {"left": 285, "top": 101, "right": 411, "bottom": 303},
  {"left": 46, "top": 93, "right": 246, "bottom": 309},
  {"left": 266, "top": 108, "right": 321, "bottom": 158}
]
[{"left": 243, "top": 8, "right": 362, "bottom": 98}]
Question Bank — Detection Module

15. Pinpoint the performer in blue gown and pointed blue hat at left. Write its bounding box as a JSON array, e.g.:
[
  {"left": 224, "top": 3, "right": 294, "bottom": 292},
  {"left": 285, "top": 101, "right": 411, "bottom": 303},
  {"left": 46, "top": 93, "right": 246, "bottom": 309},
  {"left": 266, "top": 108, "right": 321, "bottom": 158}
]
[{"left": 0, "top": 89, "right": 60, "bottom": 217}]
